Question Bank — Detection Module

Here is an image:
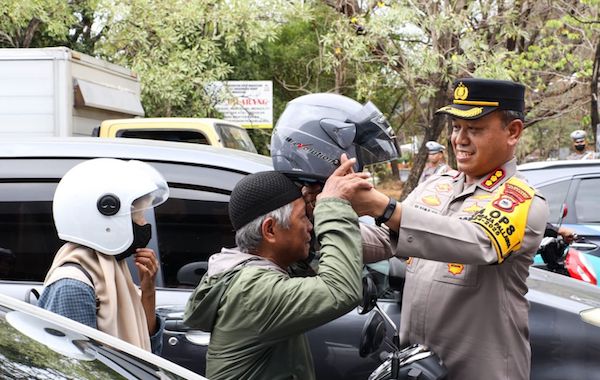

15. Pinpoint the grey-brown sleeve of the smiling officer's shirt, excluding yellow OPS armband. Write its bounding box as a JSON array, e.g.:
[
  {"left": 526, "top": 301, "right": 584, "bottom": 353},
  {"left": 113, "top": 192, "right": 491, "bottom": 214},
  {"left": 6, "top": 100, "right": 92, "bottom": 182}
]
[{"left": 396, "top": 196, "right": 548, "bottom": 265}]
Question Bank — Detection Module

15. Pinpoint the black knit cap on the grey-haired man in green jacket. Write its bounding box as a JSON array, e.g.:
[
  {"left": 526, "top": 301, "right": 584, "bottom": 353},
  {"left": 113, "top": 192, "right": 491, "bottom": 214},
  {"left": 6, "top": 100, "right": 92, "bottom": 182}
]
[{"left": 229, "top": 171, "right": 302, "bottom": 231}]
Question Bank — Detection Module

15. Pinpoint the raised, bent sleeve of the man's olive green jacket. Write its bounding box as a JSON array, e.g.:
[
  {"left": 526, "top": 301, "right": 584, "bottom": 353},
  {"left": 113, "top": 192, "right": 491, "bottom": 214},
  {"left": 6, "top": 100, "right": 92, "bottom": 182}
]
[{"left": 234, "top": 198, "right": 362, "bottom": 340}]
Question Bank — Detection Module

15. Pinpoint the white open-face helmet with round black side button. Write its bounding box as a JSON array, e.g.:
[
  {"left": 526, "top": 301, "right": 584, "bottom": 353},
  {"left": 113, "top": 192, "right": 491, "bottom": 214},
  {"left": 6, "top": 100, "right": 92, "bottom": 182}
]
[{"left": 52, "top": 158, "right": 169, "bottom": 255}]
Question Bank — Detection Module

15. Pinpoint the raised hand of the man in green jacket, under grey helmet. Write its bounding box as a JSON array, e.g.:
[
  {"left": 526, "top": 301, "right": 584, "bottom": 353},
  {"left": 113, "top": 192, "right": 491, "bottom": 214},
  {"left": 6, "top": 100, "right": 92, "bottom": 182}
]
[{"left": 317, "top": 154, "right": 373, "bottom": 208}]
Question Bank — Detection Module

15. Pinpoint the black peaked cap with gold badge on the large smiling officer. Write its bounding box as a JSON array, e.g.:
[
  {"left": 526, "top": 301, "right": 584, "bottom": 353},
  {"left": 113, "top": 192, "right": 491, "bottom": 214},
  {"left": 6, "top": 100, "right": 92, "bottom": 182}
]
[{"left": 435, "top": 78, "right": 525, "bottom": 120}]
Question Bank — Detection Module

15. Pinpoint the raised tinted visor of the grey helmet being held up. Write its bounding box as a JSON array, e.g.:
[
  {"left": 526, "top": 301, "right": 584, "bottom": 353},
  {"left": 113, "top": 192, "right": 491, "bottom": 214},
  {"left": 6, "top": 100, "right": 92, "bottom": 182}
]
[{"left": 350, "top": 102, "right": 398, "bottom": 166}]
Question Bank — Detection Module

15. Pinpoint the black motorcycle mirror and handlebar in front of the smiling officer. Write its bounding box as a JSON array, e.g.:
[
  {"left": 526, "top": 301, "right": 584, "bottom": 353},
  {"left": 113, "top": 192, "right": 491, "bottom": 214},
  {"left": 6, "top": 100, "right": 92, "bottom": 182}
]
[{"left": 358, "top": 268, "right": 448, "bottom": 380}]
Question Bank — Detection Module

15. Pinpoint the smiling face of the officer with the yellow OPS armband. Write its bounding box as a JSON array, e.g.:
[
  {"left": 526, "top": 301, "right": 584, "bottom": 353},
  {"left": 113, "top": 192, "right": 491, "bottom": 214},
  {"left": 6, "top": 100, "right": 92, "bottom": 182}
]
[{"left": 451, "top": 111, "right": 523, "bottom": 182}]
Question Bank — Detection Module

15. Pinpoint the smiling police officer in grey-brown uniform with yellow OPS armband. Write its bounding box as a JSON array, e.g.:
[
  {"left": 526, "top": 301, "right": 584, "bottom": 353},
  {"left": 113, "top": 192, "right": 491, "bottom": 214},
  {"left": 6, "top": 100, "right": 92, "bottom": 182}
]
[{"left": 357, "top": 78, "right": 548, "bottom": 380}]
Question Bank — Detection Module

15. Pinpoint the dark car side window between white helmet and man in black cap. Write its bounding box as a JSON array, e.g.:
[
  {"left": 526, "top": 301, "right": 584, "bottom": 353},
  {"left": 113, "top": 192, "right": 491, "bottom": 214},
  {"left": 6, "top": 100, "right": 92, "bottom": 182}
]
[{"left": 155, "top": 188, "right": 235, "bottom": 287}]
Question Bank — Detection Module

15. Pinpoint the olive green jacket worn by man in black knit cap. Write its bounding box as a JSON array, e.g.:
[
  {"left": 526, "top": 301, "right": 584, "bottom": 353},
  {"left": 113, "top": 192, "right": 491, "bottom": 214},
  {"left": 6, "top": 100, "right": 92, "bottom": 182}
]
[{"left": 184, "top": 198, "right": 362, "bottom": 380}]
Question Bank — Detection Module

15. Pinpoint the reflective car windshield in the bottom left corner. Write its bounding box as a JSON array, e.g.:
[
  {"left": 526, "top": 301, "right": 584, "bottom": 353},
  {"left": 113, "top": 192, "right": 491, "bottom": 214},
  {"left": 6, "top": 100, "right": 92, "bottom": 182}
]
[{"left": 0, "top": 305, "right": 188, "bottom": 380}]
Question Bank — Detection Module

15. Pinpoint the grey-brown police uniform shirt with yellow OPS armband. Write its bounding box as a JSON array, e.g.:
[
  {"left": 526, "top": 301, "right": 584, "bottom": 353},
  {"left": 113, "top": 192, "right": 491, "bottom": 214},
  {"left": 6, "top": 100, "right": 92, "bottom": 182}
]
[{"left": 396, "top": 159, "right": 548, "bottom": 380}]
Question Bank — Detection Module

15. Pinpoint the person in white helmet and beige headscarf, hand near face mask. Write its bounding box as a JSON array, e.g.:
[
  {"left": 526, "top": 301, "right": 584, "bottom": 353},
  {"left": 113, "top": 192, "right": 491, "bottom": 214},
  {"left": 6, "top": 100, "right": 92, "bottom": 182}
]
[{"left": 38, "top": 158, "right": 169, "bottom": 354}]
